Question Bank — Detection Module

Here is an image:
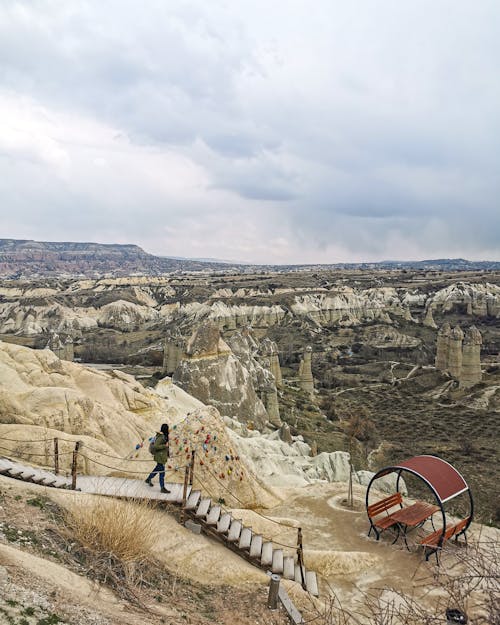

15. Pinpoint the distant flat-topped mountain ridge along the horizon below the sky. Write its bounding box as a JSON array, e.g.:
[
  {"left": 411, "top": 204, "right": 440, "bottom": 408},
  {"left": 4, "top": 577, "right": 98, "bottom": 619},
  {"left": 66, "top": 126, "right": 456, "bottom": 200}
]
[{"left": 0, "top": 239, "right": 500, "bottom": 279}]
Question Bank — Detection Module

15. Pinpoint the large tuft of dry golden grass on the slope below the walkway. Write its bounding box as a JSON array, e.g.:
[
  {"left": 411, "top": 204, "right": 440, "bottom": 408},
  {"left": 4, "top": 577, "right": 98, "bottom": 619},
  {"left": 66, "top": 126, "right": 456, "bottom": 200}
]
[{"left": 63, "top": 499, "right": 161, "bottom": 603}]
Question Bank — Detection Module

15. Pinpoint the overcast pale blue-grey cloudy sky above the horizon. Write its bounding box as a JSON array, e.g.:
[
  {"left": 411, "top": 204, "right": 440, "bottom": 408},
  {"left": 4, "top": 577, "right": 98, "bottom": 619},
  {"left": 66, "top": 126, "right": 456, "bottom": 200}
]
[{"left": 0, "top": 0, "right": 500, "bottom": 264}]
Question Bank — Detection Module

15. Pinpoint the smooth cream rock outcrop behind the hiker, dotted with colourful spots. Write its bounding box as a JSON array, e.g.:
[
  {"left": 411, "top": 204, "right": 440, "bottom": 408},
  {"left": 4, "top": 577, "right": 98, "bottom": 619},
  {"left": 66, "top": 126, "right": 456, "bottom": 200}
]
[{"left": 0, "top": 341, "right": 284, "bottom": 507}]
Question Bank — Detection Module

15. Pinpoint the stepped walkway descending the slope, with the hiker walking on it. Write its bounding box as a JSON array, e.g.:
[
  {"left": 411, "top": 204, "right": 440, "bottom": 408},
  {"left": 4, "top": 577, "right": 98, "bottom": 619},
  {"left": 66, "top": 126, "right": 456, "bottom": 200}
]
[{"left": 0, "top": 458, "right": 319, "bottom": 596}]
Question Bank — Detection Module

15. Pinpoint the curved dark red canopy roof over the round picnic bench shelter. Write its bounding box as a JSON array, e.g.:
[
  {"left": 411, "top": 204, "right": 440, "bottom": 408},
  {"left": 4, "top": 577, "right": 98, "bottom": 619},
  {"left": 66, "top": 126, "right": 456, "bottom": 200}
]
[{"left": 391, "top": 456, "right": 469, "bottom": 503}]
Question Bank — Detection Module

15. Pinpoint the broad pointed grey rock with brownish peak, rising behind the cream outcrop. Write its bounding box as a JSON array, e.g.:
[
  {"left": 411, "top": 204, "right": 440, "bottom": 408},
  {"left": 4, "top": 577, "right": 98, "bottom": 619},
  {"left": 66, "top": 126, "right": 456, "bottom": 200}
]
[{"left": 173, "top": 322, "right": 268, "bottom": 428}]
